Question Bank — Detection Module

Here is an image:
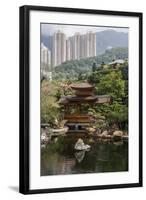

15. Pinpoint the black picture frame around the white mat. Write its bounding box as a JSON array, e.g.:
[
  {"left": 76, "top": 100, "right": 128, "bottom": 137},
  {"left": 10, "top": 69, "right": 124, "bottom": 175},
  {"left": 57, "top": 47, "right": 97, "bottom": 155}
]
[{"left": 19, "top": 6, "right": 143, "bottom": 194}]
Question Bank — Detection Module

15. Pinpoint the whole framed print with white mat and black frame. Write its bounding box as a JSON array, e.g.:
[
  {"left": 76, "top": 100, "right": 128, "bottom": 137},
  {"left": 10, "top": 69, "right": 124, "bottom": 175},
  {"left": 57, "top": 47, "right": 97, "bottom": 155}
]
[{"left": 20, "top": 6, "right": 142, "bottom": 194}]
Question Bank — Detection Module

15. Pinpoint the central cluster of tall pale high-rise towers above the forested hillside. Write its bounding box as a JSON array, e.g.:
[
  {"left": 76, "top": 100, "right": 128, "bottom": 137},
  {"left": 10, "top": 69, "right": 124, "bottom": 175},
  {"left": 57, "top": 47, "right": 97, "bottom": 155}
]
[{"left": 52, "top": 31, "right": 96, "bottom": 66}]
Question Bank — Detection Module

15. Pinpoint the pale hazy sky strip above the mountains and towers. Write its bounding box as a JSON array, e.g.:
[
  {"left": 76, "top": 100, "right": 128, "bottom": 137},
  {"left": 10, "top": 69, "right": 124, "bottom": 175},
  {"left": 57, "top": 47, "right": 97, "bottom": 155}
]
[{"left": 41, "top": 24, "right": 128, "bottom": 36}]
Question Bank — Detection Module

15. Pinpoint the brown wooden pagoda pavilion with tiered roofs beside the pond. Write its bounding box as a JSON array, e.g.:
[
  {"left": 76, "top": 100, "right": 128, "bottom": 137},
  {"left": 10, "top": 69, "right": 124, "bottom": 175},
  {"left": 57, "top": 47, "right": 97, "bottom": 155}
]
[{"left": 59, "top": 83, "right": 111, "bottom": 131}]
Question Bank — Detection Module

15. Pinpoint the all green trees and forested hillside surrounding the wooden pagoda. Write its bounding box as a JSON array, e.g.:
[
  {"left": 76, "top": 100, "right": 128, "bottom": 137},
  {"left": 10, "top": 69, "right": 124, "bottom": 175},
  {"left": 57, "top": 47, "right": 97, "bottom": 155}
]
[{"left": 41, "top": 48, "right": 128, "bottom": 130}]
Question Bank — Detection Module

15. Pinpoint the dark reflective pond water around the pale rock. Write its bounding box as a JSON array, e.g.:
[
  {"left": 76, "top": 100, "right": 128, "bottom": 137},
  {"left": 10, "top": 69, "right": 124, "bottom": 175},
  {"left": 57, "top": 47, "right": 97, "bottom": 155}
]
[{"left": 41, "top": 133, "right": 128, "bottom": 176}]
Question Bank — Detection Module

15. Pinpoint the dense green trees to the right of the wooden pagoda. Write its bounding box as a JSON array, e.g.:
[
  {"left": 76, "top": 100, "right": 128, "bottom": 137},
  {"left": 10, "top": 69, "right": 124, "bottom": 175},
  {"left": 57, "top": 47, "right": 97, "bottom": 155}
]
[{"left": 88, "top": 62, "right": 128, "bottom": 129}]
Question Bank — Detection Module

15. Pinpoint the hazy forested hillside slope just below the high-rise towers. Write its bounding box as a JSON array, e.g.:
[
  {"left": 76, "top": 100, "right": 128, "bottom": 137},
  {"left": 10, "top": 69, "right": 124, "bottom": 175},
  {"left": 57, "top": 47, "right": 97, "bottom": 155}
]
[{"left": 53, "top": 48, "right": 128, "bottom": 80}]
